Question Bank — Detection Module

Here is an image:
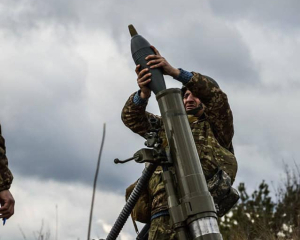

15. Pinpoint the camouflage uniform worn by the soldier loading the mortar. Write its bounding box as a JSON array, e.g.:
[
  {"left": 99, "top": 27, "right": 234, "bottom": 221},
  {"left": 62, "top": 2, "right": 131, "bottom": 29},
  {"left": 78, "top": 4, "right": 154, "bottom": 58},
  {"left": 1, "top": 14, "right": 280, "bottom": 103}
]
[{"left": 122, "top": 72, "right": 237, "bottom": 239}]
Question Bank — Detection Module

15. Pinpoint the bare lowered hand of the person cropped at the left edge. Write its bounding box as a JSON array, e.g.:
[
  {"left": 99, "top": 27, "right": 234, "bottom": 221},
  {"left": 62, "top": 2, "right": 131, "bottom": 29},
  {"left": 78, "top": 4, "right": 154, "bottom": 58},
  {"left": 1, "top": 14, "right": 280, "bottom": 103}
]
[{"left": 0, "top": 190, "right": 15, "bottom": 219}]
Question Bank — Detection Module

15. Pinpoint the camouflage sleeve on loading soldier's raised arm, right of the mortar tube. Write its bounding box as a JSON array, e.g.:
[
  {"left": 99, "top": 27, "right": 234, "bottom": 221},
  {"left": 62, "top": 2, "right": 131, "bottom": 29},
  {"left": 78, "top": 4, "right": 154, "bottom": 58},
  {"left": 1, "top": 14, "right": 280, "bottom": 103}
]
[{"left": 185, "top": 72, "right": 234, "bottom": 153}]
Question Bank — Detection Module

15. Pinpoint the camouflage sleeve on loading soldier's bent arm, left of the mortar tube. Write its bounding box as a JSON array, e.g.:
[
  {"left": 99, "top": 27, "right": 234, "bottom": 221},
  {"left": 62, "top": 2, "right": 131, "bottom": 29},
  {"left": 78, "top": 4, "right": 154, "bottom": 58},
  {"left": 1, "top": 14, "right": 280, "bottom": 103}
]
[{"left": 121, "top": 93, "right": 161, "bottom": 137}]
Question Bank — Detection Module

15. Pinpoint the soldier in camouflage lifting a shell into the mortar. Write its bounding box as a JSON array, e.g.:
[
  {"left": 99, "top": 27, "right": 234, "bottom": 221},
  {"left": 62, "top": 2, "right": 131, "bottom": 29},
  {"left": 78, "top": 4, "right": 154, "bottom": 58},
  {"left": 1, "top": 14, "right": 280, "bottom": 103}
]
[{"left": 122, "top": 46, "right": 237, "bottom": 240}]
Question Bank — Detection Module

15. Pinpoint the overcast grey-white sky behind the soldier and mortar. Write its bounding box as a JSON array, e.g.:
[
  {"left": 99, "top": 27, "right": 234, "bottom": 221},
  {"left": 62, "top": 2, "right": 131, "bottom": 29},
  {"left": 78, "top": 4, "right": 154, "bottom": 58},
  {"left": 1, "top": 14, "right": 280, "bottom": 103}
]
[{"left": 0, "top": 0, "right": 300, "bottom": 240}]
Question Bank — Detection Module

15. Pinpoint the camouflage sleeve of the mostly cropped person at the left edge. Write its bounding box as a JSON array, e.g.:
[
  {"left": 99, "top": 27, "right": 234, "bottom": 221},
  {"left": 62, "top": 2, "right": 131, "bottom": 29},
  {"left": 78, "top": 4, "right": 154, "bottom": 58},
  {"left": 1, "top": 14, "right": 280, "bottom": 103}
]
[{"left": 0, "top": 125, "right": 13, "bottom": 192}]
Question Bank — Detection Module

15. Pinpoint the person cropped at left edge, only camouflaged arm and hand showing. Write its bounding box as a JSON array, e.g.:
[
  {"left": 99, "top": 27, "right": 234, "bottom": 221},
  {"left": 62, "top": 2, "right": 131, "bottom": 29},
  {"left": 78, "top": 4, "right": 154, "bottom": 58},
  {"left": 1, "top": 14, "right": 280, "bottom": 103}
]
[{"left": 0, "top": 124, "right": 15, "bottom": 220}]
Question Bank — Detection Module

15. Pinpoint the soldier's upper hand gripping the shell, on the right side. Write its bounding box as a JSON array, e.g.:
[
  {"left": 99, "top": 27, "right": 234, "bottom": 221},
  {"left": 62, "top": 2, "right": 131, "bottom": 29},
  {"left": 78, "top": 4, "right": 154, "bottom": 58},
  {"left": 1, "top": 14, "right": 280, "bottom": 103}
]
[{"left": 146, "top": 46, "right": 180, "bottom": 78}]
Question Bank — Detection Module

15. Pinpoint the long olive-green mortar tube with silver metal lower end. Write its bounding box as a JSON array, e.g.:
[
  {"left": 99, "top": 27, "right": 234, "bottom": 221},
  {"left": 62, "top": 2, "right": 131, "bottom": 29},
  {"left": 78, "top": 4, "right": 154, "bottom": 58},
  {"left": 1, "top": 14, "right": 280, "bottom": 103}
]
[{"left": 156, "top": 89, "right": 222, "bottom": 240}]
